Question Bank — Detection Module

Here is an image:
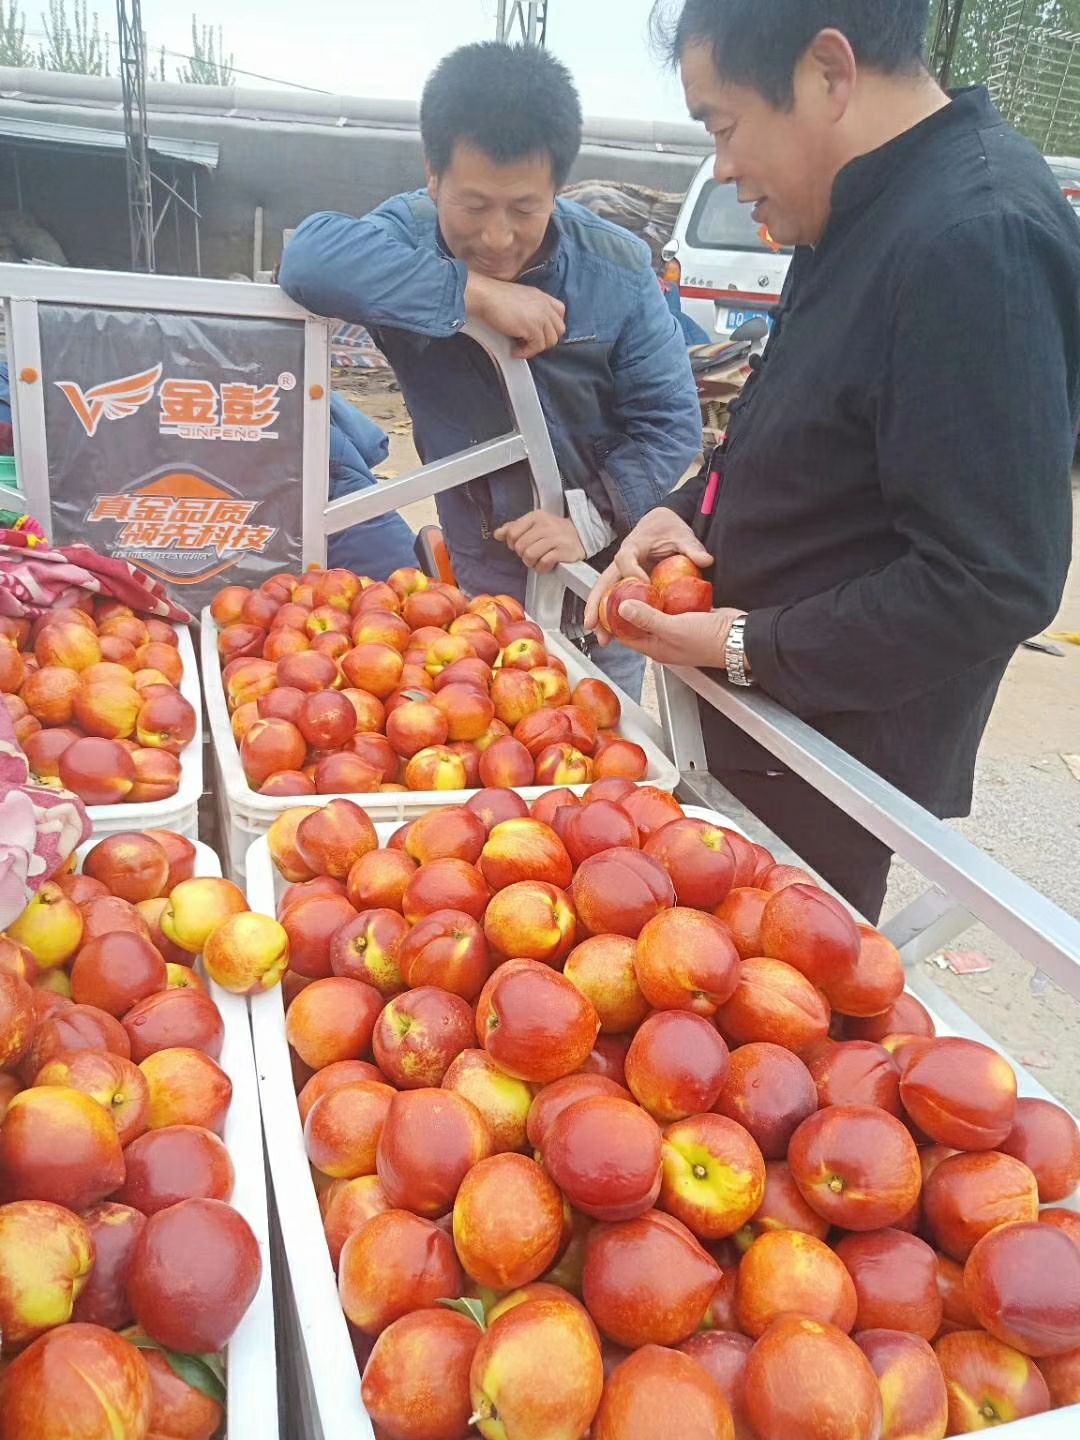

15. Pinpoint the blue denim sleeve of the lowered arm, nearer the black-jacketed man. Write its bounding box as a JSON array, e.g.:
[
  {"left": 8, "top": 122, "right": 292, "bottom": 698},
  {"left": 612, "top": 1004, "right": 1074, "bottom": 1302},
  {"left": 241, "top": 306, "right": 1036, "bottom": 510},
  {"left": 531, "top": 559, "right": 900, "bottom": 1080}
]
[{"left": 600, "top": 265, "right": 701, "bottom": 533}]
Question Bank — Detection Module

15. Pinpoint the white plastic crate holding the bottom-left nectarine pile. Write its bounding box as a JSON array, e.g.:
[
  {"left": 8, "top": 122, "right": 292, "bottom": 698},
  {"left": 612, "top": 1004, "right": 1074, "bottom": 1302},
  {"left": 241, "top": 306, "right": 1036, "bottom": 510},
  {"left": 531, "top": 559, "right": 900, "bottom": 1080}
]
[{"left": 79, "top": 835, "right": 278, "bottom": 1440}]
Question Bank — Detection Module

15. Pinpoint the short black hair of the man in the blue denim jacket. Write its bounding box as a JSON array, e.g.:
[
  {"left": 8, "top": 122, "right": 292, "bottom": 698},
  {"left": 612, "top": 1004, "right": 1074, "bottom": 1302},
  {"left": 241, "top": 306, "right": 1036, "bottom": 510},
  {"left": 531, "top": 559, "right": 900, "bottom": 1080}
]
[{"left": 420, "top": 40, "right": 582, "bottom": 189}]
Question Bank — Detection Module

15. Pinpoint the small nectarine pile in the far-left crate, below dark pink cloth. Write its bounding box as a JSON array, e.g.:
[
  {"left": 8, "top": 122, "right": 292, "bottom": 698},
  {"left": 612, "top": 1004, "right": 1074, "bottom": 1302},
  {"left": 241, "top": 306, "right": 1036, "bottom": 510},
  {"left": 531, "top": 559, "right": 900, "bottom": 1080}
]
[{"left": 0, "top": 595, "right": 196, "bottom": 805}]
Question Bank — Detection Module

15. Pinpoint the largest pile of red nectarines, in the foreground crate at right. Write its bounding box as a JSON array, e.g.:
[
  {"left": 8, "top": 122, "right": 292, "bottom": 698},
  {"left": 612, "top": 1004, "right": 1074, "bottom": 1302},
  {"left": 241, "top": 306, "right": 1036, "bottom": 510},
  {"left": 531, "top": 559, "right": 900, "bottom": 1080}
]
[{"left": 269, "top": 779, "right": 1080, "bottom": 1440}]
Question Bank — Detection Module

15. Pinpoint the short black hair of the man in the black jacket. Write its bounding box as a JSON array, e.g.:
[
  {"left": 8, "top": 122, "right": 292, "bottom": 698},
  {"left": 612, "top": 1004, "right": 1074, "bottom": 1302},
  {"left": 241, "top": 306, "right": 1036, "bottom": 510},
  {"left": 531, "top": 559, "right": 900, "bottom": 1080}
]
[{"left": 652, "top": 0, "right": 930, "bottom": 108}]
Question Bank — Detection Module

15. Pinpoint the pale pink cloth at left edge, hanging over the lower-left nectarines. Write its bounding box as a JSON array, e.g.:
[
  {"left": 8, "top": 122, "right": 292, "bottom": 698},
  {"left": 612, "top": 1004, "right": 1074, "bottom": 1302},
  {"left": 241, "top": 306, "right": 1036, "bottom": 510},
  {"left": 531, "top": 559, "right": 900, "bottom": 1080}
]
[{"left": 0, "top": 706, "right": 91, "bottom": 930}]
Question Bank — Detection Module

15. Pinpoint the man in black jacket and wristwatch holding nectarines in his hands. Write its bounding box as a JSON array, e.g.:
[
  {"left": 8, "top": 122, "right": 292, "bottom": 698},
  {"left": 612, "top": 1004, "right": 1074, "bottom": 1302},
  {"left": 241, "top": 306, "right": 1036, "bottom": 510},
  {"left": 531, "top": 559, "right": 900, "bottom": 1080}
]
[{"left": 586, "top": 0, "right": 1080, "bottom": 919}]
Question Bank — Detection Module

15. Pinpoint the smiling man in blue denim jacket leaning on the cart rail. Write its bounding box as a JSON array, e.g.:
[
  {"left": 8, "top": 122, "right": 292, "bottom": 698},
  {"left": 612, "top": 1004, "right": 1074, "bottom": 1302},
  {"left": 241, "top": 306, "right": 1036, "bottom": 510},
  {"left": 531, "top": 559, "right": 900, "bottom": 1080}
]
[{"left": 281, "top": 43, "right": 701, "bottom": 696}]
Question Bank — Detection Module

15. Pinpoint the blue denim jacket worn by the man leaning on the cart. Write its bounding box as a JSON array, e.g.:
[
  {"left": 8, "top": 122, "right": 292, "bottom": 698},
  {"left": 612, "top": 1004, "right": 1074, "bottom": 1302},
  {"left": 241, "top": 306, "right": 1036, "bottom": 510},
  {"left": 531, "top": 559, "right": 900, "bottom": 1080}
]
[{"left": 281, "top": 190, "right": 701, "bottom": 593}]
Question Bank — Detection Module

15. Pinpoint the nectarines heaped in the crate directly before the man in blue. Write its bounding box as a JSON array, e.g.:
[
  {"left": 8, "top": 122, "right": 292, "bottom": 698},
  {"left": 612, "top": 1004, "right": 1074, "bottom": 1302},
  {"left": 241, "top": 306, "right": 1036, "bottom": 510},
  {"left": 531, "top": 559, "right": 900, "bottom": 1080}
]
[{"left": 210, "top": 570, "right": 648, "bottom": 795}]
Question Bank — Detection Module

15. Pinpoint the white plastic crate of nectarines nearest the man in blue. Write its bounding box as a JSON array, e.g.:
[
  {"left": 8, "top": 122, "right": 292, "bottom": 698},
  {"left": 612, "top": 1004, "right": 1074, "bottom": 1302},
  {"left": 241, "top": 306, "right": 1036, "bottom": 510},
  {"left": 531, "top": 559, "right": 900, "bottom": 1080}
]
[{"left": 200, "top": 609, "right": 678, "bottom": 878}]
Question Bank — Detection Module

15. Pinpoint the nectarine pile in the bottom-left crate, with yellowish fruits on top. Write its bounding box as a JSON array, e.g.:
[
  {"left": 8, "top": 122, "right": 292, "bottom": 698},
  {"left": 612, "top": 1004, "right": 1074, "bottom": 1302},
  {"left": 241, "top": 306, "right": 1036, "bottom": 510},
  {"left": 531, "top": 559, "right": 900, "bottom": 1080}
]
[{"left": 0, "top": 831, "right": 269, "bottom": 1440}]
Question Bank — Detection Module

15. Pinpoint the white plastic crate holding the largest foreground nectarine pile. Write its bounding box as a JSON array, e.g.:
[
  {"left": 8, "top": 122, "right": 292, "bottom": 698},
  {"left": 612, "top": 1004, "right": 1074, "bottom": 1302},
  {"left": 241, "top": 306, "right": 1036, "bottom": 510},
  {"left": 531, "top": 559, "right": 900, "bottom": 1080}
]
[{"left": 248, "top": 823, "right": 1080, "bottom": 1440}]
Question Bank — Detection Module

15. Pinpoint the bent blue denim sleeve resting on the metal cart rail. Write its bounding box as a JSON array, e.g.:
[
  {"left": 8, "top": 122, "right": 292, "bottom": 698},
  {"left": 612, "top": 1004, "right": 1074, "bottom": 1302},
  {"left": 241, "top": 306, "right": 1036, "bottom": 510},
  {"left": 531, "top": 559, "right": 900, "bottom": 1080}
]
[{"left": 281, "top": 196, "right": 467, "bottom": 338}]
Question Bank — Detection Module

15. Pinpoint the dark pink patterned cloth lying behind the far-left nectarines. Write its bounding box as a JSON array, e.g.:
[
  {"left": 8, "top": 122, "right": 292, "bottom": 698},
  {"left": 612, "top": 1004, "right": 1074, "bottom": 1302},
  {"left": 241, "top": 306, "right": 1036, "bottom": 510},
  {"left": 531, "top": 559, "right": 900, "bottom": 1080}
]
[{"left": 0, "top": 530, "right": 192, "bottom": 625}]
